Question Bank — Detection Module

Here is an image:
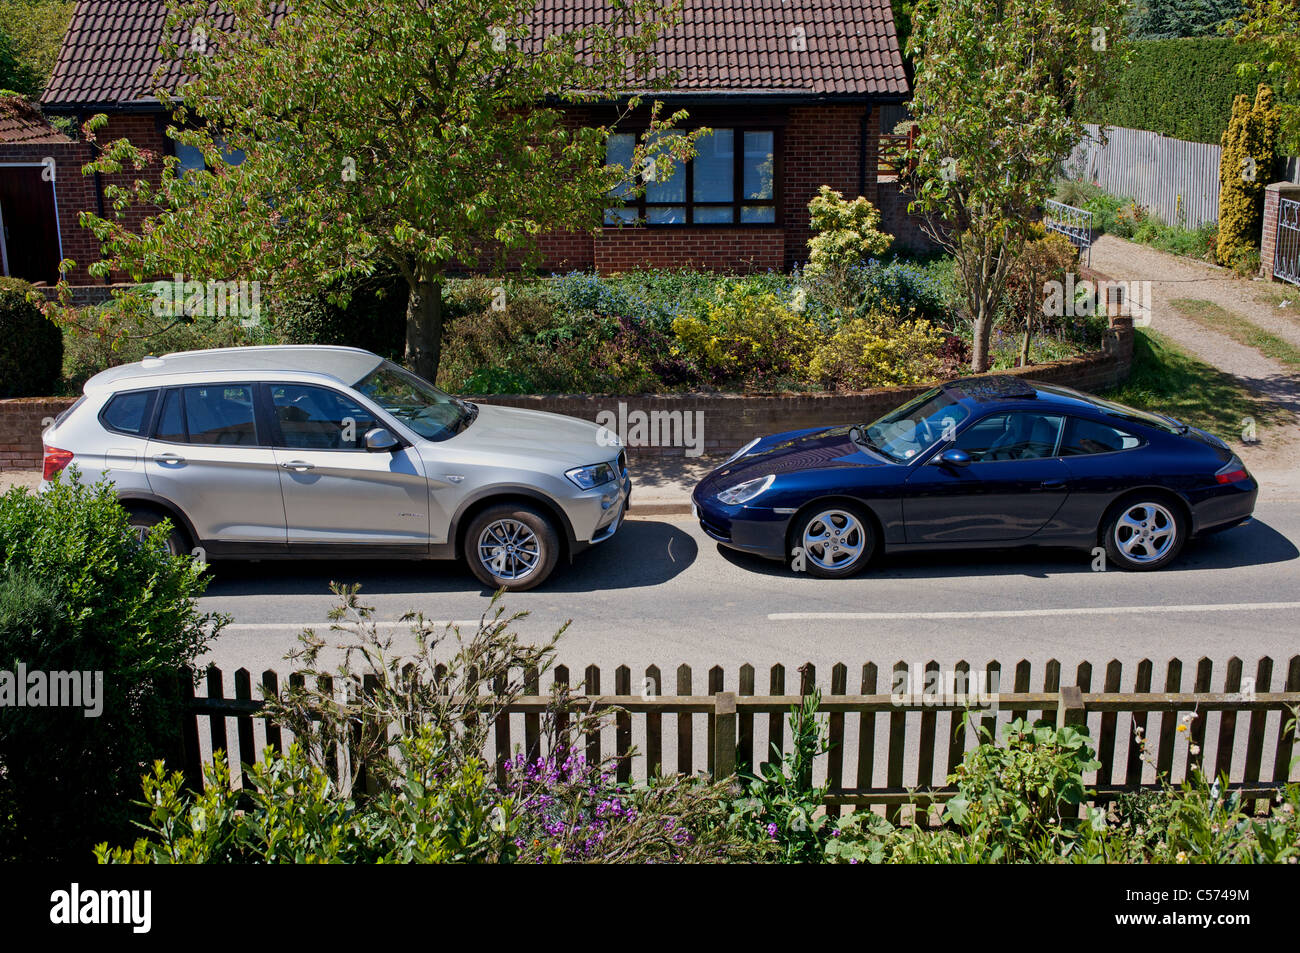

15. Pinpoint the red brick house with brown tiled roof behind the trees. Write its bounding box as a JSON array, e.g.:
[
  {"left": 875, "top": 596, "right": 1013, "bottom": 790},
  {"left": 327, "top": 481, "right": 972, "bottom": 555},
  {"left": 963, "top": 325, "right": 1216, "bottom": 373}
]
[{"left": 20, "top": 0, "right": 914, "bottom": 282}]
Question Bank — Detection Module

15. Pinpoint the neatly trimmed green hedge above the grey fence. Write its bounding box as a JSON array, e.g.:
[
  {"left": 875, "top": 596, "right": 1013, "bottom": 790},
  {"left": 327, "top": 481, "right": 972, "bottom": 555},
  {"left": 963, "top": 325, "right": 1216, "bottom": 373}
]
[{"left": 1083, "top": 36, "right": 1289, "bottom": 146}]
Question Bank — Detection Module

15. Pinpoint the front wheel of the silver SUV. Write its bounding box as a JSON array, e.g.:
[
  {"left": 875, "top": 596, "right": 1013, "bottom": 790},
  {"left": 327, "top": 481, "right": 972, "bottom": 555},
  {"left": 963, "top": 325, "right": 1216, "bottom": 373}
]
[{"left": 465, "top": 503, "right": 560, "bottom": 593}]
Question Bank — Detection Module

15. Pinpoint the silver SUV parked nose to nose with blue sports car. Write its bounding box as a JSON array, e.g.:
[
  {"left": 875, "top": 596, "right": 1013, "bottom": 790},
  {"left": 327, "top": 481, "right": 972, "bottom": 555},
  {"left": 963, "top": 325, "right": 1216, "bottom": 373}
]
[{"left": 43, "top": 346, "right": 632, "bottom": 590}]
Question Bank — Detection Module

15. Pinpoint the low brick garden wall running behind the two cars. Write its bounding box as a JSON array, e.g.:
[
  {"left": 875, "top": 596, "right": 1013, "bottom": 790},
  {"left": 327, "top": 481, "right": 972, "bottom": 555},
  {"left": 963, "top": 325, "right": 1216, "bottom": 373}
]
[{"left": 0, "top": 317, "right": 1134, "bottom": 469}]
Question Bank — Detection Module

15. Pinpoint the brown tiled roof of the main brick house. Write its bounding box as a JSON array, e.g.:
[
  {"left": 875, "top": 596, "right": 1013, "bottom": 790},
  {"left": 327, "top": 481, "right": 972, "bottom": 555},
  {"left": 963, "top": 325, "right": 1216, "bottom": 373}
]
[{"left": 42, "top": 0, "right": 907, "bottom": 108}]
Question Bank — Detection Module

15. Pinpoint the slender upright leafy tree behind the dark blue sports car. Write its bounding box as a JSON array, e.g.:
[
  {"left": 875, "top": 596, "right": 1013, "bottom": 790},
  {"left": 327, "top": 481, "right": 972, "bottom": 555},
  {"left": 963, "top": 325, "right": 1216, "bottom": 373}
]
[{"left": 906, "top": 0, "right": 1125, "bottom": 372}]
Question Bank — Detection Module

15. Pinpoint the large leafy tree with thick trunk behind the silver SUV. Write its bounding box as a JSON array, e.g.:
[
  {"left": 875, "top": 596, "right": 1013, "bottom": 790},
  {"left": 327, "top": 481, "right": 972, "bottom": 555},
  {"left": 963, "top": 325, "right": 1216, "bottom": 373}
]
[{"left": 82, "top": 0, "right": 693, "bottom": 378}]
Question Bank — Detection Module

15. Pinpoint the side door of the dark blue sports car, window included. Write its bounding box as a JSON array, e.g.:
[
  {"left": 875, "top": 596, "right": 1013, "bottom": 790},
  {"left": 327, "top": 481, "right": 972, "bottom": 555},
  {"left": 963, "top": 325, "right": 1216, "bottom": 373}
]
[{"left": 904, "top": 411, "right": 1070, "bottom": 543}]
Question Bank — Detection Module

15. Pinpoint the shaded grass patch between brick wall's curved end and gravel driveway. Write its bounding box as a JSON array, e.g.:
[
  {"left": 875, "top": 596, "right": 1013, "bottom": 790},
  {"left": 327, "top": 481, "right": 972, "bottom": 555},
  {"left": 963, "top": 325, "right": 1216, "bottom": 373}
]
[{"left": 1102, "top": 328, "right": 1287, "bottom": 442}]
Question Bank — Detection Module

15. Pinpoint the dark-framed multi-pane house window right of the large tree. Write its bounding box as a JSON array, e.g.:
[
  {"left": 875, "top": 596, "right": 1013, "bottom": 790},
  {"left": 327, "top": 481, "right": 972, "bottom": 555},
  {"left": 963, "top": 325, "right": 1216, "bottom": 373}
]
[{"left": 605, "top": 129, "right": 776, "bottom": 225}]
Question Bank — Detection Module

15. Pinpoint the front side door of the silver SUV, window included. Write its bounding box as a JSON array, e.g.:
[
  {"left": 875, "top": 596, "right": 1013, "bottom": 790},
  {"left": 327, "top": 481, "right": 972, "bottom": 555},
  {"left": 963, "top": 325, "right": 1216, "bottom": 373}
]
[{"left": 267, "top": 382, "right": 429, "bottom": 550}]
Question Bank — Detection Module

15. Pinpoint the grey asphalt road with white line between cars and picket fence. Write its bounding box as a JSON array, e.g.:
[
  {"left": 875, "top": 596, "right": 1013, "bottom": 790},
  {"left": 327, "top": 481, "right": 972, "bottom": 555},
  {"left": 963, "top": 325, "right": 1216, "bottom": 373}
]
[{"left": 202, "top": 501, "right": 1300, "bottom": 690}]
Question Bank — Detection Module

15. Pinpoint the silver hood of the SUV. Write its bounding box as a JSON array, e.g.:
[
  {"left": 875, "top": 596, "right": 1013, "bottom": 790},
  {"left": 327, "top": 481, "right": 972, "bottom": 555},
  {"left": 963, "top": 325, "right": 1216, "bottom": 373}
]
[{"left": 434, "top": 404, "right": 620, "bottom": 467}]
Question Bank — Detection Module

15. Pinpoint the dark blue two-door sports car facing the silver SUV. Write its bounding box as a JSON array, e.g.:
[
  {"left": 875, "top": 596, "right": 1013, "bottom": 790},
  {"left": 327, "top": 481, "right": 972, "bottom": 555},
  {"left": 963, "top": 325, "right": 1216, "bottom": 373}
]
[{"left": 692, "top": 376, "right": 1258, "bottom": 577}]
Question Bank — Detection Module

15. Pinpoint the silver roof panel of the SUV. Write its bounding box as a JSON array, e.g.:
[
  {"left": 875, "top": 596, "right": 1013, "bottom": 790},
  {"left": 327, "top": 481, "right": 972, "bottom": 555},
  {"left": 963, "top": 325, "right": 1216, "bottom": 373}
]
[{"left": 86, "top": 345, "right": 384, "bottom": 394}]
